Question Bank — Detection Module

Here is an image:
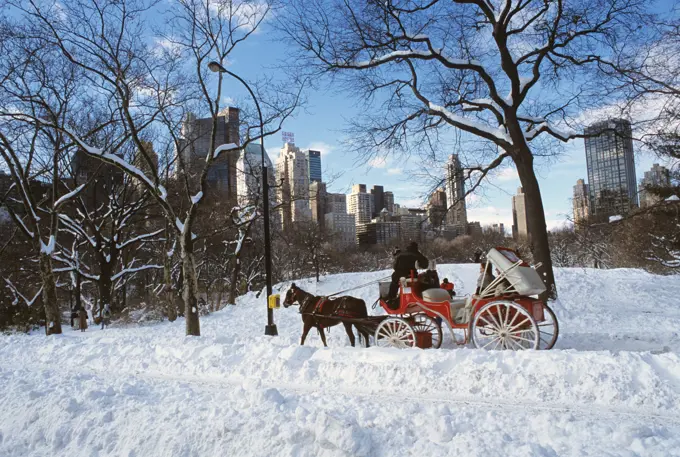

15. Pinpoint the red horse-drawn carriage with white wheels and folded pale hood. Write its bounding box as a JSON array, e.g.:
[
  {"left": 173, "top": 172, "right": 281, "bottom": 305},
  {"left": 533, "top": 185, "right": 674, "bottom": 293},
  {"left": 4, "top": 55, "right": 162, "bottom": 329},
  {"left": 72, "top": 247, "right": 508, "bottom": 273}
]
[{"left": 369, "top": 247, "right": 559, "bottom": 350}]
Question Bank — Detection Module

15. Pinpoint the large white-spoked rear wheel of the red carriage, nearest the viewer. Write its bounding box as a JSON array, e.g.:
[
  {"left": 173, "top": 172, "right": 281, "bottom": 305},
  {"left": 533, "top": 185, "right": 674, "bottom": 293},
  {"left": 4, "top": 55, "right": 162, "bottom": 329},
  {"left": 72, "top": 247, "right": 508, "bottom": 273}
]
[{"left": 470, "top": 301, "right": 539, "bottom": 350}]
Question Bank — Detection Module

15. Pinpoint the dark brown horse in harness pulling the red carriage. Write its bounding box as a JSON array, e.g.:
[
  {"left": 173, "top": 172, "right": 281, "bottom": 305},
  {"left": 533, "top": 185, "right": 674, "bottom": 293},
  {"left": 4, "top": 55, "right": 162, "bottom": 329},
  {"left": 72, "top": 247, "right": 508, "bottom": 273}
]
[{"left": 283, "top": 283, "right": 368, "bottom": 347}]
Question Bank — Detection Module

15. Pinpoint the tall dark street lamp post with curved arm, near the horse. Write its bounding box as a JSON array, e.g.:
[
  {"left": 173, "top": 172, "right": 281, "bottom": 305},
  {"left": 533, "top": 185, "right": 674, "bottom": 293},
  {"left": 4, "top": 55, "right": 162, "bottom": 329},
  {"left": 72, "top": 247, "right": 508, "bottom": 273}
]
[{"left": 208, "top": 62, "right": 279, "bottom": 336}]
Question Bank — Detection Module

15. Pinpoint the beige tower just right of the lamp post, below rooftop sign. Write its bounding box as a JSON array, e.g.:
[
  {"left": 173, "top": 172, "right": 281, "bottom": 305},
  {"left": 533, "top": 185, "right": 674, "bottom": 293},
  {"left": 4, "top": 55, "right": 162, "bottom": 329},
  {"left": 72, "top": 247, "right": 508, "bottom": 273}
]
[{"left": 276, "top": 143, "right": 312, "bottom": 230}]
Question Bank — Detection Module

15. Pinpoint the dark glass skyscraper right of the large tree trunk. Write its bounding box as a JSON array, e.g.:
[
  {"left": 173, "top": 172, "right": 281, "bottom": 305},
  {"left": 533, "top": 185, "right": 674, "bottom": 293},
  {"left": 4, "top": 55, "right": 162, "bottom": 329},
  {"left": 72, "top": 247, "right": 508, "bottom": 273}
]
[{"left": 585, "top": 119, "right": 638, "bottom": 219}]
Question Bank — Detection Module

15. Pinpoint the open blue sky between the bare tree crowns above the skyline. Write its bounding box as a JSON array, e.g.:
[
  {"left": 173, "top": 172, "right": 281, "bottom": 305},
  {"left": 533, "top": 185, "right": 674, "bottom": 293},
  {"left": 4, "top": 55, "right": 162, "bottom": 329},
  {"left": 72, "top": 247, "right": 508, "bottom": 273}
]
[{"left": 216, "top": 16, "right": 659, "bottom": 231}]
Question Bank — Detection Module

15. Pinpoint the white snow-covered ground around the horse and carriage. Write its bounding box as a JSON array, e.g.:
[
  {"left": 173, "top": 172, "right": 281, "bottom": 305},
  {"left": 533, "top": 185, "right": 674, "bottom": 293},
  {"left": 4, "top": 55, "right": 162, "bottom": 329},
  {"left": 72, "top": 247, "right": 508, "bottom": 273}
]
[{"left": 0, "top": 265, "right": 680, "bottom": 457}]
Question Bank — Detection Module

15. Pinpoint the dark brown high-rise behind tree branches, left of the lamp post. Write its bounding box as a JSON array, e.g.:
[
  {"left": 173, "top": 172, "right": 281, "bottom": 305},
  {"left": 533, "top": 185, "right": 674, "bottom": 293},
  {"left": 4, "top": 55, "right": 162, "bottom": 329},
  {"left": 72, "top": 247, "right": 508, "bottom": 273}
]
[{"left": 175, "top": 107, "right": 240, "bottom": 200}]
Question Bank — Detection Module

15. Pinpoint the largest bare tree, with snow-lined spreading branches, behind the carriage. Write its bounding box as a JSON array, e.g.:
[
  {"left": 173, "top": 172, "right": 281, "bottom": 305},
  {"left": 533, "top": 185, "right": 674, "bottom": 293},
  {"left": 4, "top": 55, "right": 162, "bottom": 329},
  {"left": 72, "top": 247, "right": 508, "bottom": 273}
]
[{"left": 281, "top": 0, "right": 643, "bottom": 302}]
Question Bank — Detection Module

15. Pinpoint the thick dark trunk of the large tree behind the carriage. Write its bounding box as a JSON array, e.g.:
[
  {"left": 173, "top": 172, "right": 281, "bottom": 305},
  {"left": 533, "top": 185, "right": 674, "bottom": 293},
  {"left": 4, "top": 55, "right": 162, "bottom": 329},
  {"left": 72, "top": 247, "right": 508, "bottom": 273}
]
[{"left": 515, "top": 149, "right": 556, "bottom": 301}]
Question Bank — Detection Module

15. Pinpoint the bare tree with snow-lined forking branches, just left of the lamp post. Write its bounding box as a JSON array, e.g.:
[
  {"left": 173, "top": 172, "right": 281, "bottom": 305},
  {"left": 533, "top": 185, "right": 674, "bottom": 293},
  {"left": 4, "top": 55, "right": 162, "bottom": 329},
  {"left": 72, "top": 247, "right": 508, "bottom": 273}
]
[{"left": 10, "top": 0, "right": 300, "bottom": 335}]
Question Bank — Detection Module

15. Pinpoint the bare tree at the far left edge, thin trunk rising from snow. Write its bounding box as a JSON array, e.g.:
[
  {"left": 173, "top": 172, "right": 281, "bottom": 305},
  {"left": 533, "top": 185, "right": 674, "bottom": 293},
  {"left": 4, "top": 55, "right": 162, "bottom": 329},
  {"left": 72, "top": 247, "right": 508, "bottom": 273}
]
[{"left": 0, "top": 28, "right": 91, "bottom": 335}]
